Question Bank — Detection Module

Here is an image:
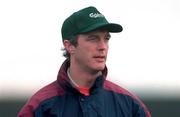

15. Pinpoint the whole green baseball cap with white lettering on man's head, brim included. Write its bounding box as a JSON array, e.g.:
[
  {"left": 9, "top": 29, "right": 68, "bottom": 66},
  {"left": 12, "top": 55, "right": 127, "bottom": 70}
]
[{"left": 61, "top": 6, "right": 123, "bottom": 40}]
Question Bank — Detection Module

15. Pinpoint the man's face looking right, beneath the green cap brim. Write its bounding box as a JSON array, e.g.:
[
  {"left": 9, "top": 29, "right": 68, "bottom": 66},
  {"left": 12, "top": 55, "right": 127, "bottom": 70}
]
[{"left": 71, "top": 31, "right": 110, "bottom": 72}]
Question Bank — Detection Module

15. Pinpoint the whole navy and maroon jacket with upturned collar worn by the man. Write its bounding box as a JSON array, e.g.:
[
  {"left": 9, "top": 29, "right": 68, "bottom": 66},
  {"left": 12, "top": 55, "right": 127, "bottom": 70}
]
[{"left": 18, "top": 61, "right": 151, "bottom": 117}]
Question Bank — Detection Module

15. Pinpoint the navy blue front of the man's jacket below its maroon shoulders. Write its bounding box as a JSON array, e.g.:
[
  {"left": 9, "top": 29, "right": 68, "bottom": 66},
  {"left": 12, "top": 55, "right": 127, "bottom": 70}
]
[{"left": 32, "top": 82, "right": 147, "bottom": 117}]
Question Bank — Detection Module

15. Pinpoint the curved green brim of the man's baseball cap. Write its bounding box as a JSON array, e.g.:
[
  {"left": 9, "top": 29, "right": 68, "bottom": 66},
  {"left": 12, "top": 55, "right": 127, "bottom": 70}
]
[{"left": 81, "top": 23, "right": 123, "bottom": 33}]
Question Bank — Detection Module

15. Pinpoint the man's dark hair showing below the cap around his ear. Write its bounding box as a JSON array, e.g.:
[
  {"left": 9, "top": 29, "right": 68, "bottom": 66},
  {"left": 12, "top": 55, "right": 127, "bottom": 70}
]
[{"left": 62, "top": 36, "right": 78, "bottom": 59}]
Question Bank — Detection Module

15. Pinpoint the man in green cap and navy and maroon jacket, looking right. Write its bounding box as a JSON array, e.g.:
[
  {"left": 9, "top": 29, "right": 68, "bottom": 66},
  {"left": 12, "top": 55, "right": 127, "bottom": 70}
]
[{"left": 18, "top": 7, "right": 151, "bottom": 117}]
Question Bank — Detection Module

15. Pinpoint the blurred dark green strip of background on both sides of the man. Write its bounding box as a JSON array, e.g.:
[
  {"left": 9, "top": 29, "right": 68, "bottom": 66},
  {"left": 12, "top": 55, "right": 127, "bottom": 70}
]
[{"left": 0, "top": 98, "right": 180, "bottom": 117}]
